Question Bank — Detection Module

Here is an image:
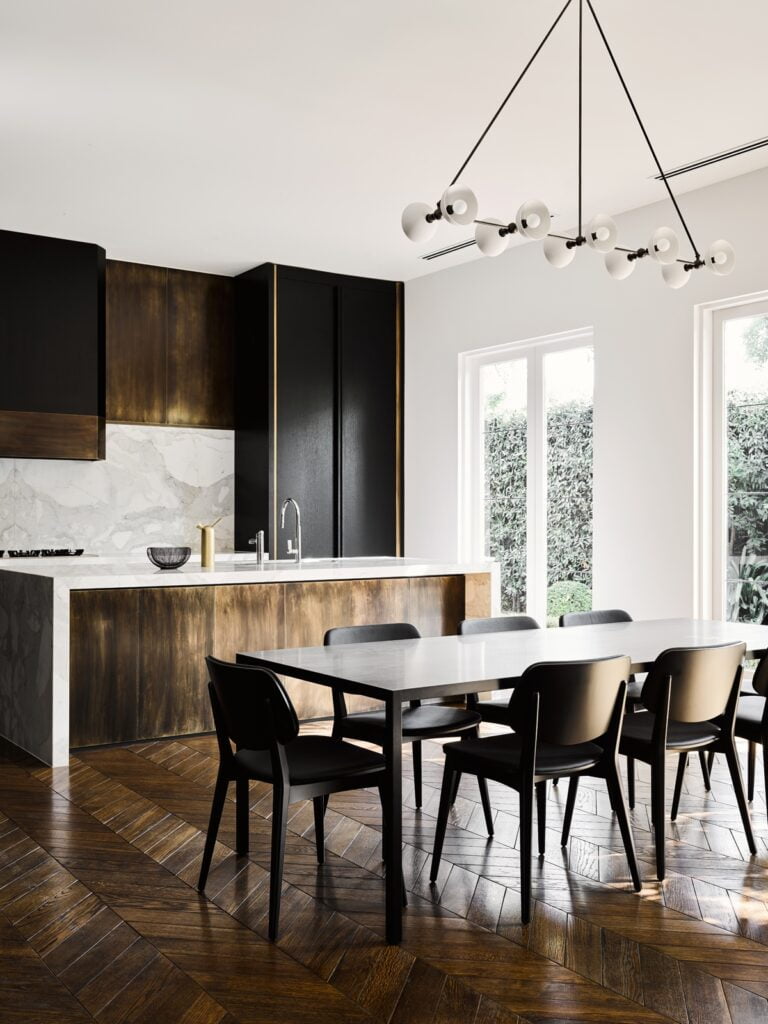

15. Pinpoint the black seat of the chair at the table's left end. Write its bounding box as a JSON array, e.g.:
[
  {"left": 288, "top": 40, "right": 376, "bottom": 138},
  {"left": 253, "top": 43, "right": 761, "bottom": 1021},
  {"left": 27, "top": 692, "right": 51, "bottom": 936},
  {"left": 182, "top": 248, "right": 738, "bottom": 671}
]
[{"left": 234, "top": 736, "right": 385, "bottom": 785}]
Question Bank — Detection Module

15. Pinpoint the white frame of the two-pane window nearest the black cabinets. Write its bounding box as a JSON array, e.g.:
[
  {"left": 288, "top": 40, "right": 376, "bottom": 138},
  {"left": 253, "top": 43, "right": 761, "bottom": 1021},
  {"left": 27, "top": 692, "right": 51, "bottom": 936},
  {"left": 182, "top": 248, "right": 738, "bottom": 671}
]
[{"left": 459, "top": 327, "right": 596, "bottom": 623}]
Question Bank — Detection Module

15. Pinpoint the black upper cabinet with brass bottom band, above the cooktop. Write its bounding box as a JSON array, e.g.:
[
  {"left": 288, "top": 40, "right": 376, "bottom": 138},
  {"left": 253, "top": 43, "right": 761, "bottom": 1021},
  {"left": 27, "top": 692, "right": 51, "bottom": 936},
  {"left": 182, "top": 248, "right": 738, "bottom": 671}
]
[{"left": 0, "top": 231, "right": 105, "bottom": 459}]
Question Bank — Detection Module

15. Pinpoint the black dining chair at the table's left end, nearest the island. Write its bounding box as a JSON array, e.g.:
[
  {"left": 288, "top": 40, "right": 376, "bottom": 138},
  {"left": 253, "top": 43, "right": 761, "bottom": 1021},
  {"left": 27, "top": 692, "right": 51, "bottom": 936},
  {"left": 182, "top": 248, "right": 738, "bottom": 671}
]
[{"left": 198, "top": 656, "right": 387, "bottom": 941}]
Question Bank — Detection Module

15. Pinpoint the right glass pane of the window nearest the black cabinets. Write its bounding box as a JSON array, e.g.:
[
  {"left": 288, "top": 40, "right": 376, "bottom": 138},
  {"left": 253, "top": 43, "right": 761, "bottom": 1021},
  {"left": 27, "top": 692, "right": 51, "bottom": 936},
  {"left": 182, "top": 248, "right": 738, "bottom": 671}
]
[{"left": 544, "top": 347, "right": 594, "bottom": 626}]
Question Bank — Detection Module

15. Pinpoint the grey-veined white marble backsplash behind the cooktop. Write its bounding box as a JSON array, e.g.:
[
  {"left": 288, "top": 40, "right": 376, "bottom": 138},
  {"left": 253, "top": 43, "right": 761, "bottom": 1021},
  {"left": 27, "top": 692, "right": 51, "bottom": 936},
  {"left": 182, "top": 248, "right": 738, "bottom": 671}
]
[{"left": 0, "top": 424, "right": 234, "bottom": 555}]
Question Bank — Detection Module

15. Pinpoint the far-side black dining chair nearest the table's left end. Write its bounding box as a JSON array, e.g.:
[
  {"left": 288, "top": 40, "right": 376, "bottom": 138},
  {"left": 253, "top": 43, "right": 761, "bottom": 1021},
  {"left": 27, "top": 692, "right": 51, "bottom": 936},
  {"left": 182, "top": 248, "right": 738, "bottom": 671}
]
[{"left": 324, "top": 623, "right": 494, "bottom": 836}]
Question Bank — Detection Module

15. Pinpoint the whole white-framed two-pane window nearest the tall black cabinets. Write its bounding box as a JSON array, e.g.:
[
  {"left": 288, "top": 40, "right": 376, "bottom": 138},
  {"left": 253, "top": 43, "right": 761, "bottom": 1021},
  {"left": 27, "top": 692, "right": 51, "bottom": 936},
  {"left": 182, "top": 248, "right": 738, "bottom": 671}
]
[{"left": 460, "top": 331, "right": 593, "bottom": 625}]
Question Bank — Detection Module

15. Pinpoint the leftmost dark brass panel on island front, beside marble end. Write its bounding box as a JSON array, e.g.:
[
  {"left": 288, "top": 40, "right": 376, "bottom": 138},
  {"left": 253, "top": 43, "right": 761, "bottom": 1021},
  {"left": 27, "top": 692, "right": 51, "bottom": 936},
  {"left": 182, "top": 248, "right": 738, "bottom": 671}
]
[{"left": 70, "top": 590, "right": 141, "bottom": 746}]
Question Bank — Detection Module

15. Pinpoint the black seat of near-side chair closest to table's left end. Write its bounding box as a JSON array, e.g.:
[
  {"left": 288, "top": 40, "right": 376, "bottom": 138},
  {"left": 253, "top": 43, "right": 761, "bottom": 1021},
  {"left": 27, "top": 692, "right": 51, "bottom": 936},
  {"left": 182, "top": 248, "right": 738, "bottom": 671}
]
[{"left": 444, "top": 732, "right": 603, "bottom": 778}]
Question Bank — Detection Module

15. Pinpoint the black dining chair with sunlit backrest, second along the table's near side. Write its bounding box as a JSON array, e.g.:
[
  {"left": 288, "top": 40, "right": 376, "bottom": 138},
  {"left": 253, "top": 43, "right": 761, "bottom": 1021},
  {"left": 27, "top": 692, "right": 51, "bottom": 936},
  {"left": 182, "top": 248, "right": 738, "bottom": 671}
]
[{"left": 620, "top": 643, "right": 757, "bottom": 881}]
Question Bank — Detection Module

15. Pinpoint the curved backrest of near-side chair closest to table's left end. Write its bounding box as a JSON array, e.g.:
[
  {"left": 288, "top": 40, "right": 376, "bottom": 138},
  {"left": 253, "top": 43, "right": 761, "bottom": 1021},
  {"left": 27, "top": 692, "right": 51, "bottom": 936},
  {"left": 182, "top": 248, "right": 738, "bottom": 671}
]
[{"left": 509, "top": 655, "right": 632, "bottom": 746}]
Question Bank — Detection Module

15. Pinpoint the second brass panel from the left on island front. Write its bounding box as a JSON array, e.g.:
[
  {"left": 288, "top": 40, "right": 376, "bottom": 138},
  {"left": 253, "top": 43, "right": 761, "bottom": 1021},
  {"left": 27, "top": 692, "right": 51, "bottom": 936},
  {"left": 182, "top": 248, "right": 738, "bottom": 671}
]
[{"left": 138, "top": 587, "right": 215, "bottom": 737}]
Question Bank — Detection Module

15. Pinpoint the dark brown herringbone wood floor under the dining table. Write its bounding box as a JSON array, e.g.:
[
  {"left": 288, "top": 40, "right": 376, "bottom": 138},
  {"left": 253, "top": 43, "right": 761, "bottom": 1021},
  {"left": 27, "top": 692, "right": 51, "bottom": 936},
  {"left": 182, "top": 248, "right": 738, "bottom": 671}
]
[{"left": 0, "top": 726, "right": 768, "bottom": 1024}]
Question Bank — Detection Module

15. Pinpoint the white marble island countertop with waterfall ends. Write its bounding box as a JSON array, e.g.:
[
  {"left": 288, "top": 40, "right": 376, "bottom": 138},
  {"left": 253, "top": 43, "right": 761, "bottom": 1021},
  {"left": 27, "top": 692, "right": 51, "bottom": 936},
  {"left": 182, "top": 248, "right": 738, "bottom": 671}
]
[{"left": 0, "top": 554, "right": 500, "bottom": 767}]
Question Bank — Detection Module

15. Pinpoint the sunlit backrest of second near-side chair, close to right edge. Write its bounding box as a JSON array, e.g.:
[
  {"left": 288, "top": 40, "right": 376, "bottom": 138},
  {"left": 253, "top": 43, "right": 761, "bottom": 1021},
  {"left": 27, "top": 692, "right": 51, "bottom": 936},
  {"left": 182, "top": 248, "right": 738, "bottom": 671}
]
[{"left": 640, "top": 643, "right": 746, "bottom": 722}]
